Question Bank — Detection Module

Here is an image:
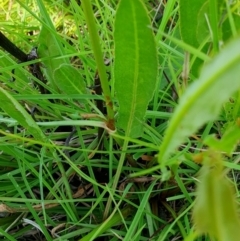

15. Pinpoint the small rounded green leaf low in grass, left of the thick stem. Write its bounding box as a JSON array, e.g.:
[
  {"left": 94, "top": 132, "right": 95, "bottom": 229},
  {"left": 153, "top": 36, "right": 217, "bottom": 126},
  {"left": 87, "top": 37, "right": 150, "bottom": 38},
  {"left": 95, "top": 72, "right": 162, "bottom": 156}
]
[{"left": 54, "top": 64, "right": 86, "bottom": 94}]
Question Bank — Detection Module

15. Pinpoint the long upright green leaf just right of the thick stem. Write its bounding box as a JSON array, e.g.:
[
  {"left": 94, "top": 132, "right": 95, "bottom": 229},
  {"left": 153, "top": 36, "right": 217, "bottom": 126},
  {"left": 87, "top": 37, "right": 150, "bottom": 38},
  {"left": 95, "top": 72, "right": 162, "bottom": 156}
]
[{"left": 114, "top": 0, "right": 157, "bottom": 137}]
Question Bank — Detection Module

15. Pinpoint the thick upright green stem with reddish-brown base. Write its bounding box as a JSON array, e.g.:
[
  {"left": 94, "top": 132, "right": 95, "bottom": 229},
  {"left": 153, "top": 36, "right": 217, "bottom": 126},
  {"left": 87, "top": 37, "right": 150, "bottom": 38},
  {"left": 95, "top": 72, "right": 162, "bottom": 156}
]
[{"left": 81, "top": 0, "right": 115, "bottom": 130}]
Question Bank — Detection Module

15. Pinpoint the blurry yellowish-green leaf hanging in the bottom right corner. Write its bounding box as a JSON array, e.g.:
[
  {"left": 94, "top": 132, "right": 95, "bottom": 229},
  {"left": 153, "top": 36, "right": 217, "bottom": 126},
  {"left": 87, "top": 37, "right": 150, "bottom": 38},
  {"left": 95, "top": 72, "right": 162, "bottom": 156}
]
[{"left": 193, "top": 152, "right": 240, "bottom": 241}]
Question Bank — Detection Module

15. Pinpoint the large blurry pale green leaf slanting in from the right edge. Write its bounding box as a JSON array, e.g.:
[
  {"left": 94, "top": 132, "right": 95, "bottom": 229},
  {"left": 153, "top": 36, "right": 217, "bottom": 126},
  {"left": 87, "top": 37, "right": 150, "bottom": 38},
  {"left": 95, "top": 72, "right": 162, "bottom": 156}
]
[{"left": 158, "top": 38, "right": 240, "bottom": 165}]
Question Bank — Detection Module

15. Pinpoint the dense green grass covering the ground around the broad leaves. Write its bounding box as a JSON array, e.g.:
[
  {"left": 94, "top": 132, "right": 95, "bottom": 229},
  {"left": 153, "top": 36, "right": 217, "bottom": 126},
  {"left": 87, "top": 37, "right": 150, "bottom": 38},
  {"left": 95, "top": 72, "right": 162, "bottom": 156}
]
[{"left": 0, "top": 0, "right": 239, "bottom": 241}]
